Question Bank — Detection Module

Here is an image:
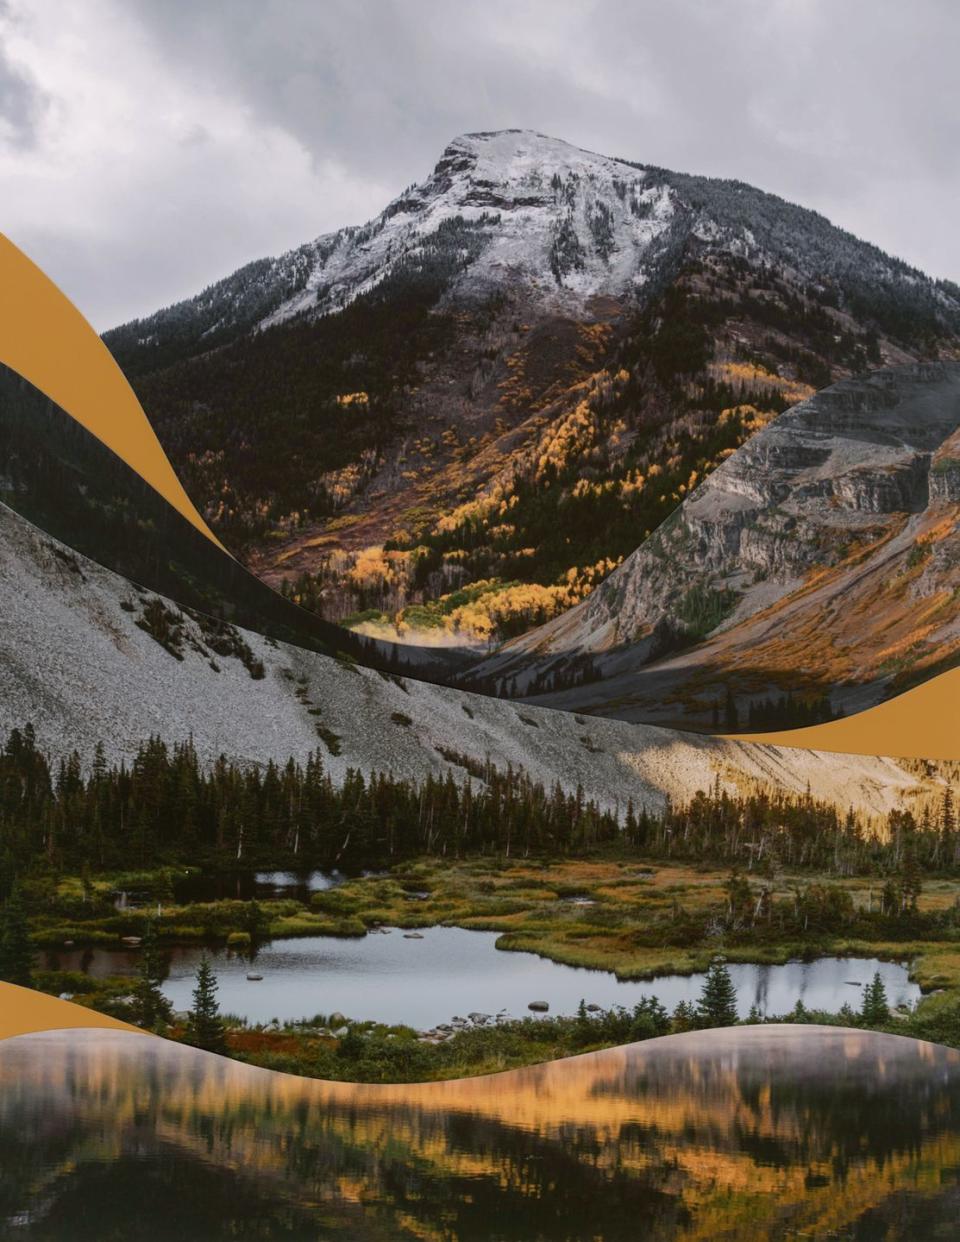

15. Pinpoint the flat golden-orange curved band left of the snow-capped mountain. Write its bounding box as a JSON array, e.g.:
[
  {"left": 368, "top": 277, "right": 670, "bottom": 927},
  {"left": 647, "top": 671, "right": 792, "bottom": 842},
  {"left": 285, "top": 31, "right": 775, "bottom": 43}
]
[{"left": 0, "top": 233, "right": 222, "bottom": 546}]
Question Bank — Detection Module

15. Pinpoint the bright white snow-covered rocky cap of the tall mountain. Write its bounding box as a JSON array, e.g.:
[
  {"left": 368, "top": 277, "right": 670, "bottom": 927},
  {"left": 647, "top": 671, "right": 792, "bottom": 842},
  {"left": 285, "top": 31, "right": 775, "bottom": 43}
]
[{"left": 260, "top": 129, "right": 674, "bottom": 327}]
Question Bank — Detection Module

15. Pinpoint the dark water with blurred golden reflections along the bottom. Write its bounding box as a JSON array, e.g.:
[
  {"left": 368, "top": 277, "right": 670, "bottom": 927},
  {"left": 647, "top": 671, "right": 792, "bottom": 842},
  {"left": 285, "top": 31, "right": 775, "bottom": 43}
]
[{"left": 0, "top": 1026, "right": 960, "bottom": 1242}]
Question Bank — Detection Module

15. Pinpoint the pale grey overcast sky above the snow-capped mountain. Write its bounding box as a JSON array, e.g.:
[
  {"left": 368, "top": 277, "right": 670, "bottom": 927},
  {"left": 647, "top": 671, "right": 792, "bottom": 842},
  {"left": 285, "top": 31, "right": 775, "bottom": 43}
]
[{"left": 0, "top": 0, "right": 960, "bottom": 329}]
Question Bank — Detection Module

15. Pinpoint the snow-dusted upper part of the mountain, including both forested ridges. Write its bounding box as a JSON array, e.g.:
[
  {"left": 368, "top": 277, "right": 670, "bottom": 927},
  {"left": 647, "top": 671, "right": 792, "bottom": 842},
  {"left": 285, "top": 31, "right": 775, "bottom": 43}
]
[{"left": 106, "top": 129, "right": 960, "bottom": 371}]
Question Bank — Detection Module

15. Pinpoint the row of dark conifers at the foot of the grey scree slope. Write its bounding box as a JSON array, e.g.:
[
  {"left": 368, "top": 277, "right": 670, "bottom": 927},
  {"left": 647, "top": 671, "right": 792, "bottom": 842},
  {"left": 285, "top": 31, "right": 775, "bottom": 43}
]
[{"left": 0, "top": 725, "right": 960, "bottom": 889}]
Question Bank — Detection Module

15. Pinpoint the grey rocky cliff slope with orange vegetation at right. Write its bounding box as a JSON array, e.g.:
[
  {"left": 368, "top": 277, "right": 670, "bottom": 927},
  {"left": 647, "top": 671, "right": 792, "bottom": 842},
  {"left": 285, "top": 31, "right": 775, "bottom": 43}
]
[{"left": 469, "top": 364, "right": 960, "bottom": 719}]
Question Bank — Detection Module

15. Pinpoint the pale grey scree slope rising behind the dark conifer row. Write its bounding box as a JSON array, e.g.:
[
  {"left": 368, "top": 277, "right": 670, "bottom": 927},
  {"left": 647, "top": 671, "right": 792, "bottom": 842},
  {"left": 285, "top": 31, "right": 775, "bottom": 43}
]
[{"left": 0, "top": 494, "right": 936, "bottom": 812}]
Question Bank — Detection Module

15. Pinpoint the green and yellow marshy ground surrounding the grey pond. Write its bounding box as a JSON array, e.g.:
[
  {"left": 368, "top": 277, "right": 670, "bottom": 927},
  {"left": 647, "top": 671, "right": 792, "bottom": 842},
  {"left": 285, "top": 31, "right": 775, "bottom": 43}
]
[{"left": 20, "top": 852, "right": 960, "bottom": 1082}]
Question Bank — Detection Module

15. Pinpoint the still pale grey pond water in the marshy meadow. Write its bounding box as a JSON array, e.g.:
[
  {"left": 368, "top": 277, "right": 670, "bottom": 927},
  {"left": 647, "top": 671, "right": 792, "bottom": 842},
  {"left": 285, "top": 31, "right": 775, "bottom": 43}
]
[{"left": 50, "top": 927, "right": 920, "bottom": 1030}]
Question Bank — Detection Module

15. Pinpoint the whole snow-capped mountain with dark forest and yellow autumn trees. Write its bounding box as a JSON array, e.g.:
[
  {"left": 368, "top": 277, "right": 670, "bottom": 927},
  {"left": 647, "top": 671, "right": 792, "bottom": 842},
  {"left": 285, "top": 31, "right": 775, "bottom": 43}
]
[{"left": 106, "top": 130, "right": 960, "bottom": 715}]
